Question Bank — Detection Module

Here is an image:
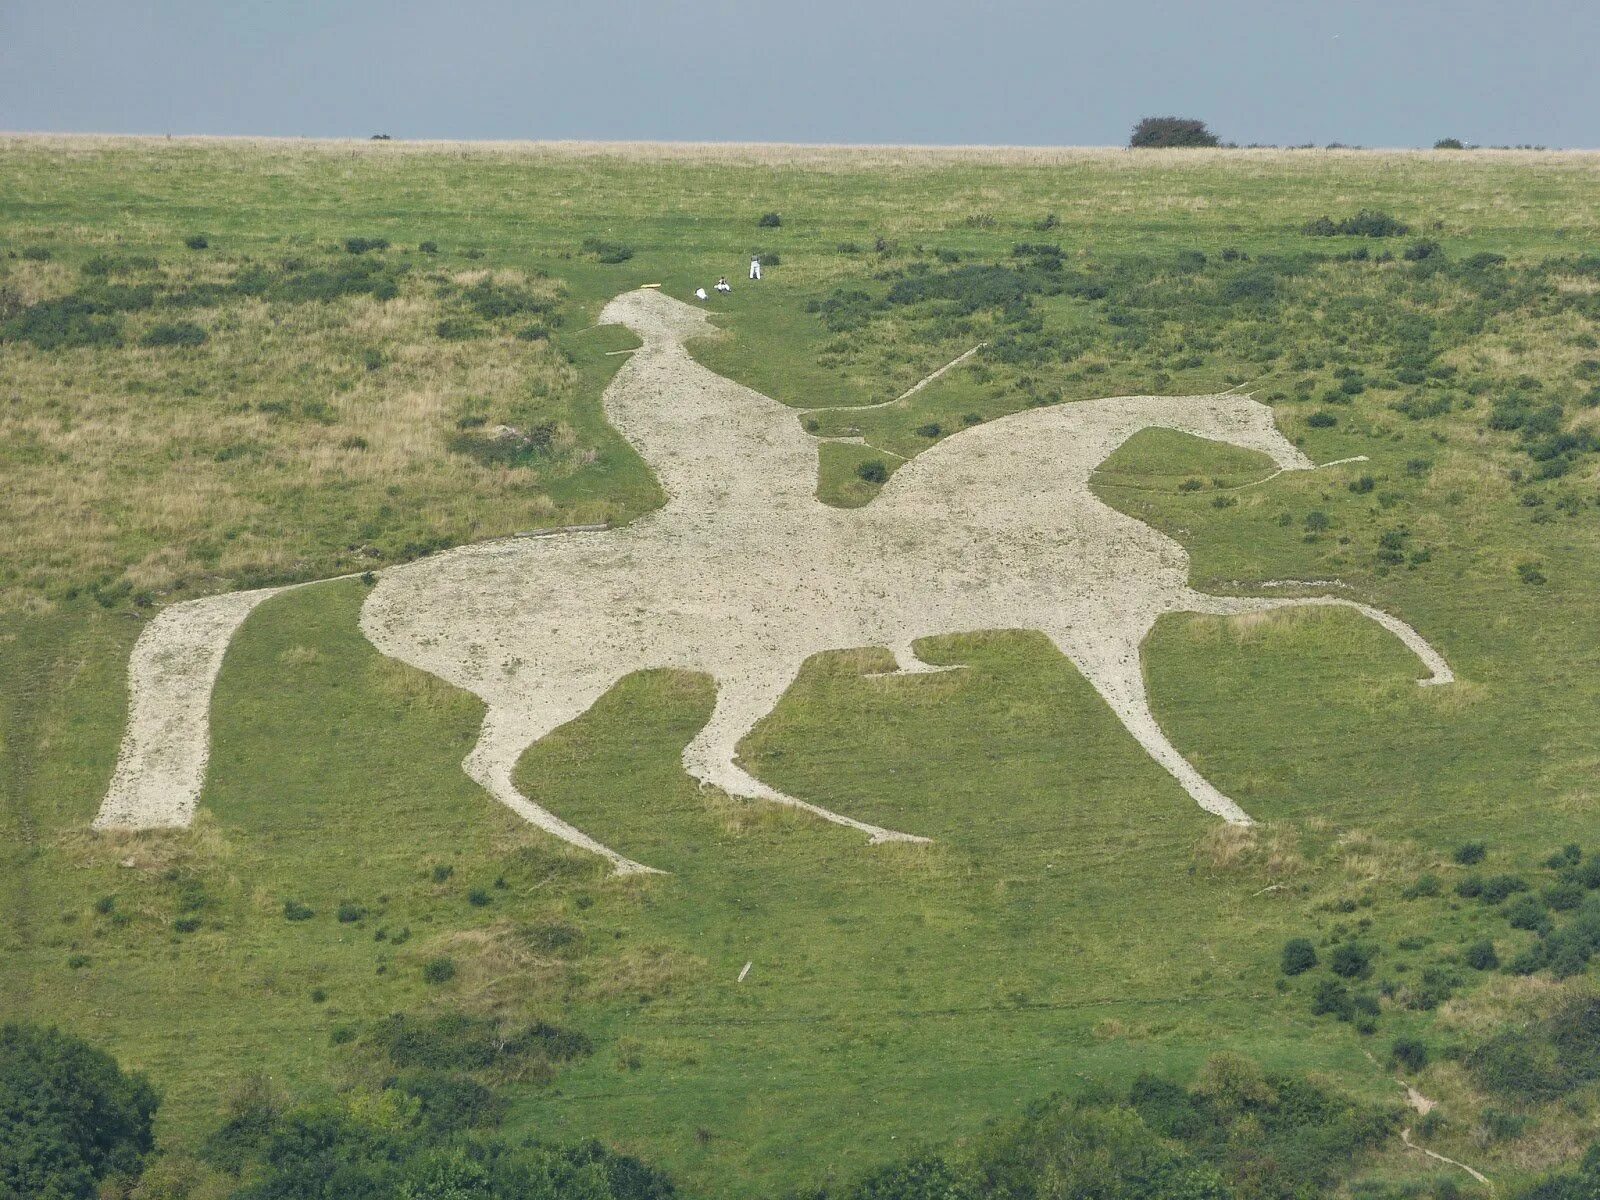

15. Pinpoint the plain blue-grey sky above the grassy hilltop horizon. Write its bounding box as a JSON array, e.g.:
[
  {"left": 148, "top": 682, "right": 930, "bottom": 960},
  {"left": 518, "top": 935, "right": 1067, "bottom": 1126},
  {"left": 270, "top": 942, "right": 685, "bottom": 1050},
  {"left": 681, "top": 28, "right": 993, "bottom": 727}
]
[{"left": 0, "top": 0, "right": 1600, "bottom": 147}]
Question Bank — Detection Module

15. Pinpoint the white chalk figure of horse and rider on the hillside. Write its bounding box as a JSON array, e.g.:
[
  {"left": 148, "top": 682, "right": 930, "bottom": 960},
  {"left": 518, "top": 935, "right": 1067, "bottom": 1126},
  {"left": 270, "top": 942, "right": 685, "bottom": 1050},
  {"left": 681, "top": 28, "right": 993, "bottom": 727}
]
[{"left": 96, "top": 290, "right": 1453, "bottom": 874}]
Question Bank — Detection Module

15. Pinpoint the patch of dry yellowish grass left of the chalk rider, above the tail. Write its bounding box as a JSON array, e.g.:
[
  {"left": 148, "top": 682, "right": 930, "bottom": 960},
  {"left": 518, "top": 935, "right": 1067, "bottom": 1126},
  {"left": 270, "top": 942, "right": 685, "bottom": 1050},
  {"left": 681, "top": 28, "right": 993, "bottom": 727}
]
[{"left": 0, "top": 262, "right": 617, "bottom": 605}]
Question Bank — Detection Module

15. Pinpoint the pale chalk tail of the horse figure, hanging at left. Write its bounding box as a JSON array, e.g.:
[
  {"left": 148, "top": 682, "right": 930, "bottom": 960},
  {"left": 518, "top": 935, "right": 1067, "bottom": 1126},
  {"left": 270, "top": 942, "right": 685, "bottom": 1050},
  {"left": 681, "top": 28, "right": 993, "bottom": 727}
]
[{"left": 94, "top": 584, "right": 296, "bottom": 829}]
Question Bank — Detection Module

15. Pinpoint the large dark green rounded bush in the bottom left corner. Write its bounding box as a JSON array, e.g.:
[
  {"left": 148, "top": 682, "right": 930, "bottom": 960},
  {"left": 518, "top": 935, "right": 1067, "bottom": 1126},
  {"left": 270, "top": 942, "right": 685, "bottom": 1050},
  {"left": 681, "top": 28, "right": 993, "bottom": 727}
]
[{"left": 0, "top": 1024, "right": 157, "bottom": 1200}]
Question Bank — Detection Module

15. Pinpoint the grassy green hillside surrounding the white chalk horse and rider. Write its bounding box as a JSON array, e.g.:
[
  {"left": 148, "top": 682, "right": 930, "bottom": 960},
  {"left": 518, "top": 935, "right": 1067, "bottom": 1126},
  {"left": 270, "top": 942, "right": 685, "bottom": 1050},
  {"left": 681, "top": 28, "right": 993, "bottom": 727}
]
[{"left": 0, "top": 138, "right": 1600, "bottom": 1197}]
